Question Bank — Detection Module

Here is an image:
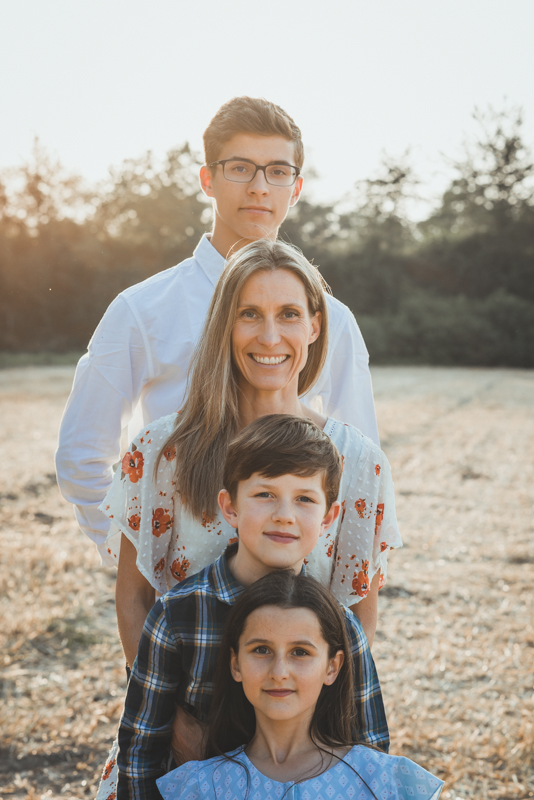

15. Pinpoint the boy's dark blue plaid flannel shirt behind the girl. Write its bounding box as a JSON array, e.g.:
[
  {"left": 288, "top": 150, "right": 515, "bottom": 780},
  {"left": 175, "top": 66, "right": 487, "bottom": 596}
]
[{"left": 117, "top": 545, "right": 389, "bottom": 800}]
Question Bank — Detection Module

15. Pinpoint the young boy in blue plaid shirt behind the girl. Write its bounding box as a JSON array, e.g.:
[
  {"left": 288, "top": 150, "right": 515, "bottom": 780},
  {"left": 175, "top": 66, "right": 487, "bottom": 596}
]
[{"left": 117, "top": 415, "right": 389, "bottom": 800}]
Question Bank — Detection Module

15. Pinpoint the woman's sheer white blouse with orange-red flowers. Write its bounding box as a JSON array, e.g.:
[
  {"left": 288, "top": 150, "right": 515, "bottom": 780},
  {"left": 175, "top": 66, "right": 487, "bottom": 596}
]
[{"left": 100, "top": 414, "right": 402, "bottom": 606}]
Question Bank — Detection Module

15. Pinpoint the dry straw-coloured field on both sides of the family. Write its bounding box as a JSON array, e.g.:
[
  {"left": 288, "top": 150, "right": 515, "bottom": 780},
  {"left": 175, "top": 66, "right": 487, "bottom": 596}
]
[{"left": 0, "top": 367, "right": 534, "bottom": 800}]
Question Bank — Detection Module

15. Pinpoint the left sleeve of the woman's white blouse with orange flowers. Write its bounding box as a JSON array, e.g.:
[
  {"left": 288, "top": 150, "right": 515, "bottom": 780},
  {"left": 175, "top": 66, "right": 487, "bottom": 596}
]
[{"left": 100, "top": 414, "right": 176, "bottom": 594}]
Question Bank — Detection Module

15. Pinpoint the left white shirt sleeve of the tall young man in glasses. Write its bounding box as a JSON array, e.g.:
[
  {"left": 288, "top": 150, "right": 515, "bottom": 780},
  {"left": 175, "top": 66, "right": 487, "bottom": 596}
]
[{"left": 56, "top": 295, "right": 152, "bottom": 563}]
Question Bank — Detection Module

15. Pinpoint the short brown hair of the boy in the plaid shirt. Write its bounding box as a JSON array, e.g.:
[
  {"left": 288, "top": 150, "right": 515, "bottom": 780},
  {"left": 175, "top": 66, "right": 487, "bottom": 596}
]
[{"left": 223, "top": 414, "right": 342, "bottom": 511}]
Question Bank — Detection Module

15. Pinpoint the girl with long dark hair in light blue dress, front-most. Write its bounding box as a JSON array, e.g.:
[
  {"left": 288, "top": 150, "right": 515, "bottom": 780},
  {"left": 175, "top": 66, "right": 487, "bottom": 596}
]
[{"left": 157, "top": 571, "right": 443, "bottom": 800}]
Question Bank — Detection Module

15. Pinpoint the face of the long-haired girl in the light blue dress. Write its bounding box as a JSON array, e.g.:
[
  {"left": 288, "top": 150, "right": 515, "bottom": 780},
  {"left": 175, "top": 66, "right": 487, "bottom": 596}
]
[{"left": 230, "top": 606, "right": 344, "bottom": 721}]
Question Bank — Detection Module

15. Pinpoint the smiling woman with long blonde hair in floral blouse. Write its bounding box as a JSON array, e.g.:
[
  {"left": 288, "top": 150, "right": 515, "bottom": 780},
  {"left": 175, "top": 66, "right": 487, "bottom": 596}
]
[{"left": 101, "top": 240, "right": 402, "bottom": 664}]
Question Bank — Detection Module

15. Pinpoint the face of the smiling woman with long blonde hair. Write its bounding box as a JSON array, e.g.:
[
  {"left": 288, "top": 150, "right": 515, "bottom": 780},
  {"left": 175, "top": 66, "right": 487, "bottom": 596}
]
[{"left": 232, "top": 269, "right": 321, "bottom": 396}]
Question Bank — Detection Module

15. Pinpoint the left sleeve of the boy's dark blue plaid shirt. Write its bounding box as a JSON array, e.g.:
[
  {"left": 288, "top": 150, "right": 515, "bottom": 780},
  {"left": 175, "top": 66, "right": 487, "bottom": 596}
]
[{"left": 117, "top": 600, "right": 183, "bottom": 800}]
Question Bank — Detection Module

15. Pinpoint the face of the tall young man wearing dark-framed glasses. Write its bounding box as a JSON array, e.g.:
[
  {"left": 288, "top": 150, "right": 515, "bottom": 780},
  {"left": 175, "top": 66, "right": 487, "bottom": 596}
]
[{"left": 200, "top": 133, "right": 302, "bottom": 255}]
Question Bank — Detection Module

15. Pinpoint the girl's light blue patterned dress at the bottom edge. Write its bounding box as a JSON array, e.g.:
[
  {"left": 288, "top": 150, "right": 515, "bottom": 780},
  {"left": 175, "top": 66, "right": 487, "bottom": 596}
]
[{"left": 157, "top": 745, "right": 443, "bottom": 800}]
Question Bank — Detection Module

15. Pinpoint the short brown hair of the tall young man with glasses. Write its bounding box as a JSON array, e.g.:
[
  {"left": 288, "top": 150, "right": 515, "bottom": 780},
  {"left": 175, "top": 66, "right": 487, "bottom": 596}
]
[{"left": 203, "top": 96, "right": 304, "bottom": 167}]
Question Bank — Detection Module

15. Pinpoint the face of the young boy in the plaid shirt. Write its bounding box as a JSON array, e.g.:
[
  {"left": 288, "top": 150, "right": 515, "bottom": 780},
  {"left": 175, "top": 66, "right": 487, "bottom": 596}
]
[{"left": 219, "top": 472, "right": 339, "bottom": 585}]
